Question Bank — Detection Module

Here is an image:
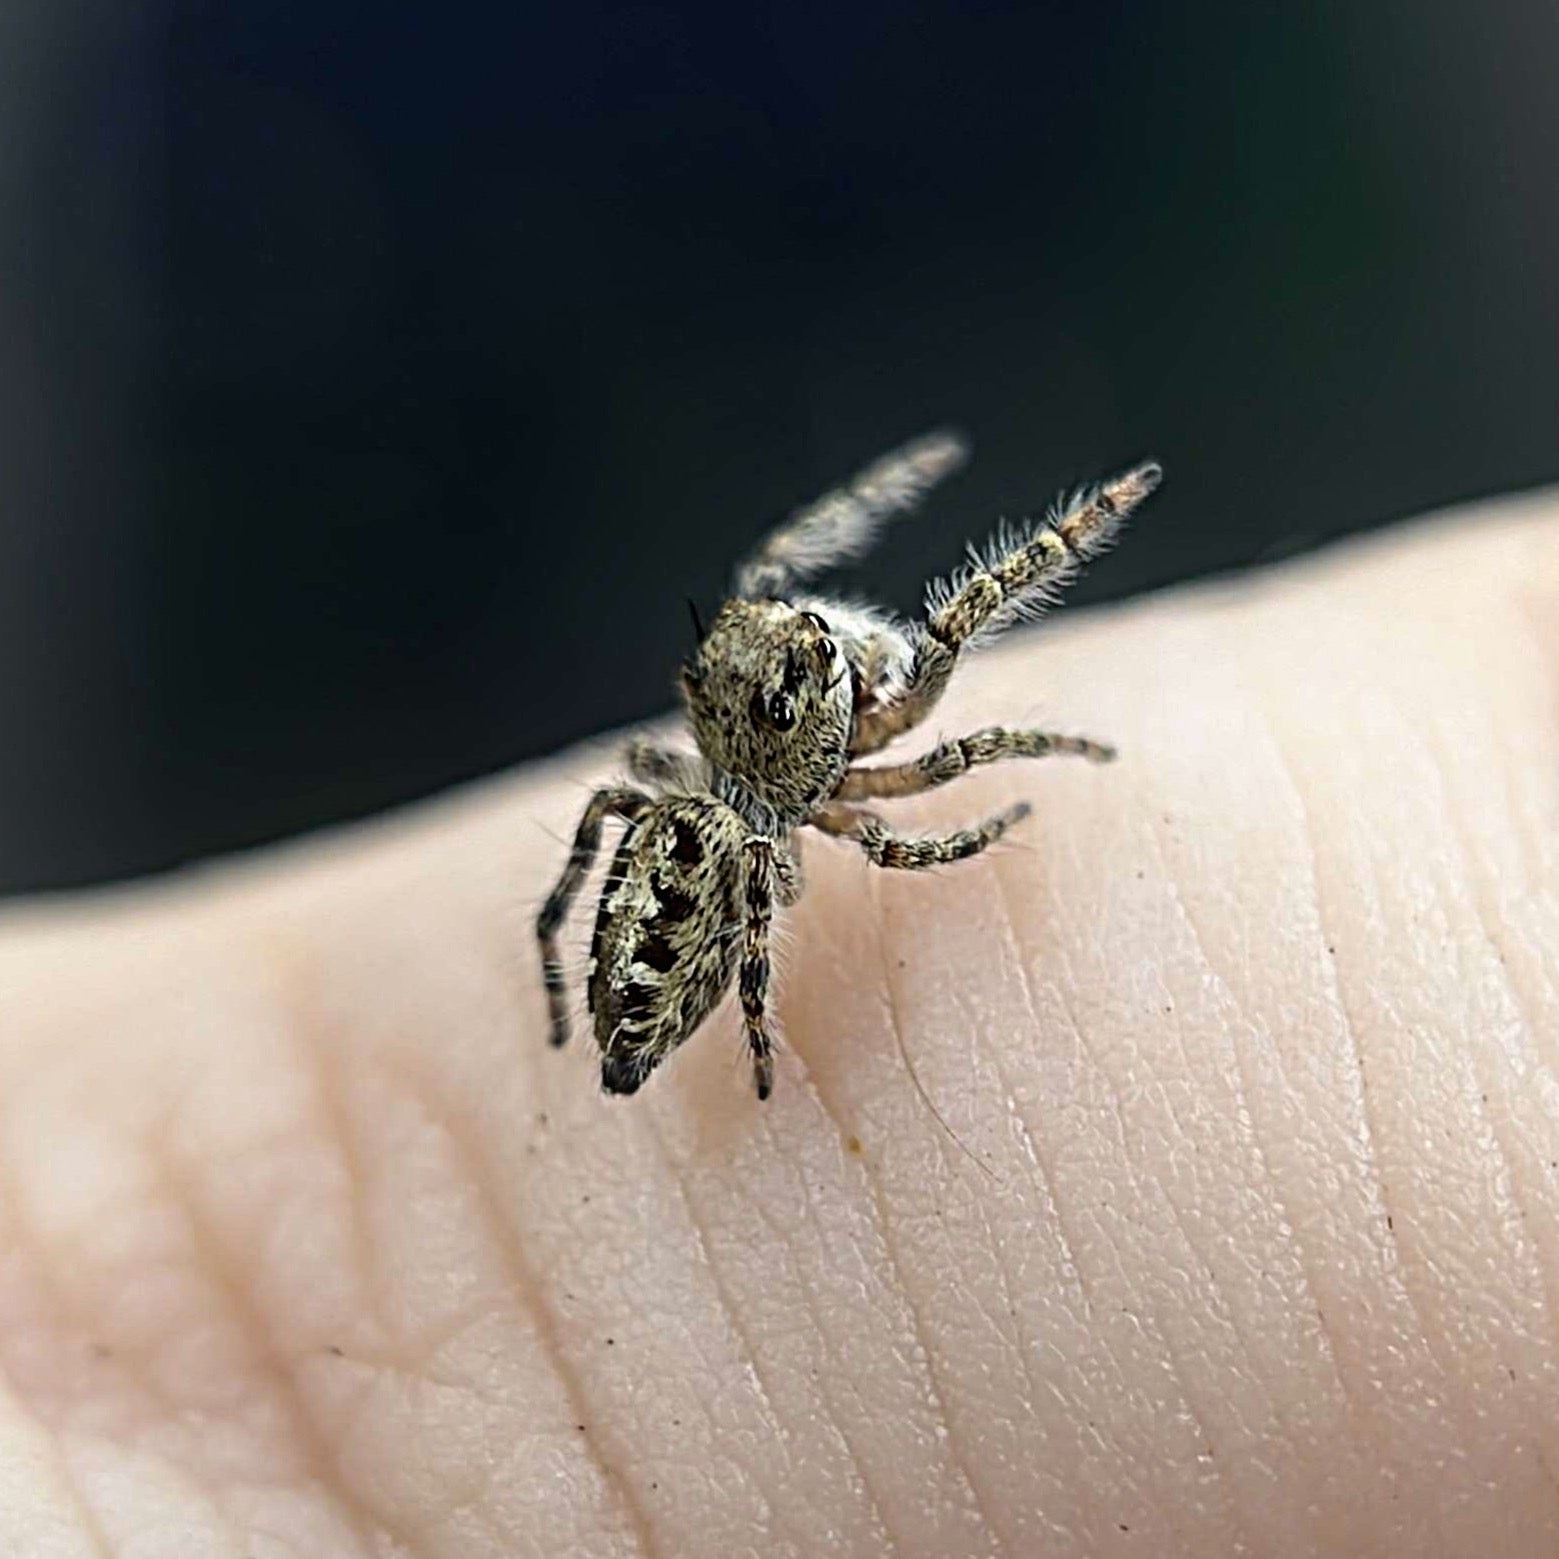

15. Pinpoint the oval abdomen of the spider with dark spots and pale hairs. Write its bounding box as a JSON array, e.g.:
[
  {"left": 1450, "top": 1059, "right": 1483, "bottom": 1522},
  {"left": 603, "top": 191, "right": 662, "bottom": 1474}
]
[{"left": 586, "top": 795, "right": 748, "bottom": 1093}]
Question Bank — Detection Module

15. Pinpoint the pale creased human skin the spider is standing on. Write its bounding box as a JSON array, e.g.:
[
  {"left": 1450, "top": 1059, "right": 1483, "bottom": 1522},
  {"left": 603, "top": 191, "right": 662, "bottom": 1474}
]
[{"left": 0, "top": 496, "right": 1559, "bottom": 1559}]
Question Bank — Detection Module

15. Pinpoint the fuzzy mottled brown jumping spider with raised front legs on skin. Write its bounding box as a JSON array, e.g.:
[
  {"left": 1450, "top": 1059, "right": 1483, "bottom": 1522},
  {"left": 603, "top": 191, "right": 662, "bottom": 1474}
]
[{"left": 536, "top": 433, "right": 1160, "bottom": 1099}]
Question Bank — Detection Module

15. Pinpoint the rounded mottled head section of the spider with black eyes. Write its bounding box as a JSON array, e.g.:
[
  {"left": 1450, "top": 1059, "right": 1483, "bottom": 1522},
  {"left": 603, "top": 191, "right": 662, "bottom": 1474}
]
[{"left": 681, "top": 600, "right": 854, "bottom": 822}]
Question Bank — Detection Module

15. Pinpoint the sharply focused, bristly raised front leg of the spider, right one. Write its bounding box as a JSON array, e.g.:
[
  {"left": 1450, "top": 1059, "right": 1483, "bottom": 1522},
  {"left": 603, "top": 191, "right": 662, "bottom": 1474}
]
[{"left": 851, "top": 463, "right": 1161, "bottom": 755}]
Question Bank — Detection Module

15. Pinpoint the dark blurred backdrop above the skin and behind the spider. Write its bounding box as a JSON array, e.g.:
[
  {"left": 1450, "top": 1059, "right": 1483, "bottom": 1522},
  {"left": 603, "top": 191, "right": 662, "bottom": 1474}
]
[{"left": 0, "top": 0, "right": 1559, "bottom": 890}]
